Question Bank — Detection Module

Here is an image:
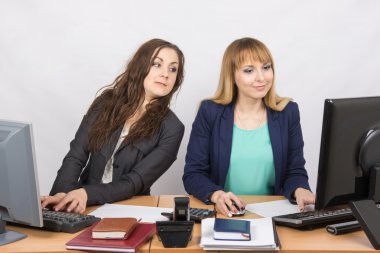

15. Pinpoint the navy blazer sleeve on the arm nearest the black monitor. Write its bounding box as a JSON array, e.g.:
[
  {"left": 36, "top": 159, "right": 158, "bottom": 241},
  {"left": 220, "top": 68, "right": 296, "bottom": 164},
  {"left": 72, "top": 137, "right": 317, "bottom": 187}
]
[{"left": 283, "top": 102, "right": 310, "bottom": 200}]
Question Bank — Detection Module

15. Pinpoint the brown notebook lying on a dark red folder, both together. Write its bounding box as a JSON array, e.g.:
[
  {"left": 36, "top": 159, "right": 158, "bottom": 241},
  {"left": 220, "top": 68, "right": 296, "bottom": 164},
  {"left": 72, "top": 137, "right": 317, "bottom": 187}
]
[{"left": 66, "top": 218, "right": 156, "bottom": 252}]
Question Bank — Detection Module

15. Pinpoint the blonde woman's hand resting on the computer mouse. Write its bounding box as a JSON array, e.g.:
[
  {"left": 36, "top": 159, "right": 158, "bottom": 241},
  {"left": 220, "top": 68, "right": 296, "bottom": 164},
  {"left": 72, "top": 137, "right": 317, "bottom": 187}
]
[{"left": 210, "top": 190, "right": 245, "bottom": 217}]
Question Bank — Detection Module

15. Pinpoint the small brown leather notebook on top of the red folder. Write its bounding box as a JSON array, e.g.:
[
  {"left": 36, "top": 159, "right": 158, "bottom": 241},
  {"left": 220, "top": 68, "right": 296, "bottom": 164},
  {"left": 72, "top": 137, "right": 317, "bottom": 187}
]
[{"left": 92, "top": 218, "right": 137, "bottom": 239}]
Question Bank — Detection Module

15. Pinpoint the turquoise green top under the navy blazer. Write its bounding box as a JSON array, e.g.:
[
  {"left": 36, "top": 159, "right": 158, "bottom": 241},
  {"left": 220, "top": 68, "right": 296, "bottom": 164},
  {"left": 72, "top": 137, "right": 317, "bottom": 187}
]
[{"left": 224, "top": 123, "right": 275, "bottom": 195}]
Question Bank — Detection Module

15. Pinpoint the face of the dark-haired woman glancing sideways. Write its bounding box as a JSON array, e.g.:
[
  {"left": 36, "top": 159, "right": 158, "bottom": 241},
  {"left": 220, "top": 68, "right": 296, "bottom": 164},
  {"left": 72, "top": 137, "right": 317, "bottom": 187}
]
[{"left": 144, "top": 48, "right": 179, "bottom": 101}]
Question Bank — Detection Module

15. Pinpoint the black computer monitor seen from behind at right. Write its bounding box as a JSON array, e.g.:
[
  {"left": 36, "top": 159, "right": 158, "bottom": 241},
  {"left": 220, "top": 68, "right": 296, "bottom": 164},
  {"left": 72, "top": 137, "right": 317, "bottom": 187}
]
[{"left": 315, "top": 97, "right": 380, "bottom": 210}]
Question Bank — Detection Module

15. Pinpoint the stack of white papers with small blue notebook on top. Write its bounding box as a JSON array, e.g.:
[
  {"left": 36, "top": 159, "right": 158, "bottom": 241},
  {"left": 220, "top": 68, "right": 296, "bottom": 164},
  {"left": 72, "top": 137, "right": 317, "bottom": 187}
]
[{"left": 200, "top": 218, "right": 279, "bottom": 251}]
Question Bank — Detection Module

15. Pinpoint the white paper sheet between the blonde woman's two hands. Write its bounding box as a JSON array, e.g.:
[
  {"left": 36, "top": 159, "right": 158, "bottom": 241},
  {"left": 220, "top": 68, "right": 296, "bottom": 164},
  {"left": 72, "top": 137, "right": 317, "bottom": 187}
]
[{"left": 245, "top": 199, "right": 314, "bottom": 217}]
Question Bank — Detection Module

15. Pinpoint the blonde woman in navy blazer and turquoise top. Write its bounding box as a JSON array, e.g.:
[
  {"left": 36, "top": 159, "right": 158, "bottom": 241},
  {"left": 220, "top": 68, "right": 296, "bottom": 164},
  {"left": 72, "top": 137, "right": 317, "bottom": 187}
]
[{"left": 183, "top": 38, "right": 315, "bottom": 216}]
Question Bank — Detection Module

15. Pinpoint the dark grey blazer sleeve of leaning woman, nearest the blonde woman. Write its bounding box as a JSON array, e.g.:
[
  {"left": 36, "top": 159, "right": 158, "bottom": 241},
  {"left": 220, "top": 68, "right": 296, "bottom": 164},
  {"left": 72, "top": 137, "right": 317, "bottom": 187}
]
[{"left": 82, "top": 115, "right": 185, "bottom": 205}]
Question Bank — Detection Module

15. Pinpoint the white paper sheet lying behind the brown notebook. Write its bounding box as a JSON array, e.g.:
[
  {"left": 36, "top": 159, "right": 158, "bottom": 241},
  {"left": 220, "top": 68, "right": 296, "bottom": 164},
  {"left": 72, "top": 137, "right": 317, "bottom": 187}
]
[{"left": 90, "top": 204, "right": 173, "bottom": 222}]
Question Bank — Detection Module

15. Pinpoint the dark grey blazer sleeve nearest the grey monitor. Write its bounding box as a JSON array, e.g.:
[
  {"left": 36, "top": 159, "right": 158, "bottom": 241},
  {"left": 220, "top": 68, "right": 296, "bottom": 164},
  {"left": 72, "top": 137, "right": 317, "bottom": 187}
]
[{"left": 50, "top": 115, "right": 90, "bottom": 195}]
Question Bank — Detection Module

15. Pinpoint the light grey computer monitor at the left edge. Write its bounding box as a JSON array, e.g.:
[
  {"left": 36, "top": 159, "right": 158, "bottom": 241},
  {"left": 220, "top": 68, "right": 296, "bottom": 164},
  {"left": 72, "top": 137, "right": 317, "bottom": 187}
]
[{"left": 0, "top": 120, "right": 43, "bottom": 245}]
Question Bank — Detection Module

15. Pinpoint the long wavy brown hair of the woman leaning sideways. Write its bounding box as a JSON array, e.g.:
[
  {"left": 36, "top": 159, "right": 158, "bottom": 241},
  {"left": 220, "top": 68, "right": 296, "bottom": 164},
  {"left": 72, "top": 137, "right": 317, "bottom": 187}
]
[{"left": 88, "top": 39, "right": 185, "bottom": 152}]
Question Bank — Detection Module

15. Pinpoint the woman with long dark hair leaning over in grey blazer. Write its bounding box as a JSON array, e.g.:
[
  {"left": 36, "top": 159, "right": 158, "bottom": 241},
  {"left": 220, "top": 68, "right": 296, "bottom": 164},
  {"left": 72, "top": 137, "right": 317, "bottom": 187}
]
[{"left": 41, "top": 39, "right": 184, "bottom": 213}]
